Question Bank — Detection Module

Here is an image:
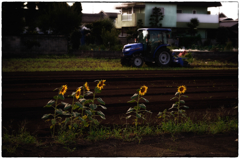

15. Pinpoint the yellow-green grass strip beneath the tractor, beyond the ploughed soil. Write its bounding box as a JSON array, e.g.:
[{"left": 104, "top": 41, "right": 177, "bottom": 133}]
[{"left": 2, "top": 56, "right": 238, "bottom": 72}]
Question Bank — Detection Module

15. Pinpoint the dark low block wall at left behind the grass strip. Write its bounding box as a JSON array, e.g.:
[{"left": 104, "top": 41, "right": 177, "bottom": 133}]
[{"left": 2, "top": 35, "right": 68, "bottom": 54}]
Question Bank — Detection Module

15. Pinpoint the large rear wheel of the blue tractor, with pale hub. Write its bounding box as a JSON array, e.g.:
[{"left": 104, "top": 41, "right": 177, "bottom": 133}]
[{"left": 155, "top": 49, "right": 172, "bottom": 66}]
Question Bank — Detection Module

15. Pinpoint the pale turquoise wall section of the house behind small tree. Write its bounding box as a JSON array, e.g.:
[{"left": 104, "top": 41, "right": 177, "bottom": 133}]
[{"left": 145, "top": 3, "right": 177, "bottom": 27}]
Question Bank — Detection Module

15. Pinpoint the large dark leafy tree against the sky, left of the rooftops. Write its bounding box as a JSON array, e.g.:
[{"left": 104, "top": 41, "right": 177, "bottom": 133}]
[{"left": 38, "top": 2, "right": 82, "bottom": 35}]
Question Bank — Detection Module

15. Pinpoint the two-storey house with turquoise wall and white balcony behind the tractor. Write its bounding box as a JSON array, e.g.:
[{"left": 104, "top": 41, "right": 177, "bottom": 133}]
[{"left": 115, "top": 2, "right": 222, "bottom": 43}]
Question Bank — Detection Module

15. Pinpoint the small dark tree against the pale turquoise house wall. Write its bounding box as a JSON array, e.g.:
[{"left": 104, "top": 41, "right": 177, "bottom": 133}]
[{"left": 149, "top": 7, "right": 163, "bottom": 28}]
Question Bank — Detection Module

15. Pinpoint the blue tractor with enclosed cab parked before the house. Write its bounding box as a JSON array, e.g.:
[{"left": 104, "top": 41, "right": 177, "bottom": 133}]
[{"left": 121, "top": 28, "right": 186, "bottom": 67}]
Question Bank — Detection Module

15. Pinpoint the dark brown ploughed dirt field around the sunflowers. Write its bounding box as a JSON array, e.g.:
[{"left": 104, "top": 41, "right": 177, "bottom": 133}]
[{"left": 2, "top": 70, "right": 238, "bottom": 157}]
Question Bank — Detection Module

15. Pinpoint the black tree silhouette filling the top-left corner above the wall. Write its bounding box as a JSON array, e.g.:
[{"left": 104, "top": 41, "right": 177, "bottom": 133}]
[{"left": 2, "top": 2, "right": 25, "bottom": 35}]
